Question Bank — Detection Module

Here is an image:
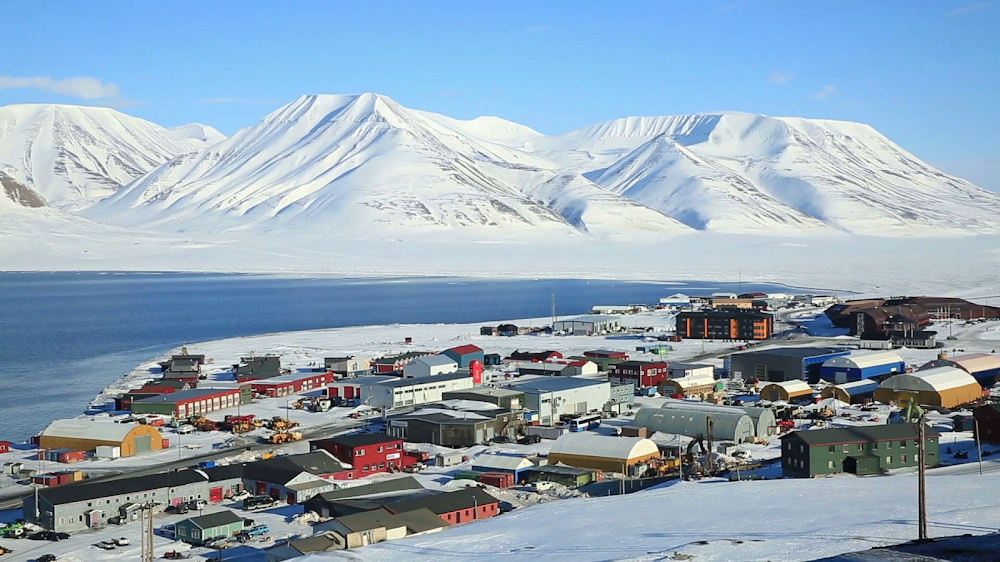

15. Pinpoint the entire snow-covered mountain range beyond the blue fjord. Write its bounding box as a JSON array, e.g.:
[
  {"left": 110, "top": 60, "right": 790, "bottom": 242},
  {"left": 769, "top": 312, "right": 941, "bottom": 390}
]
[{"left": 0, "top": 94, "right": 1000, "bottom": 238}]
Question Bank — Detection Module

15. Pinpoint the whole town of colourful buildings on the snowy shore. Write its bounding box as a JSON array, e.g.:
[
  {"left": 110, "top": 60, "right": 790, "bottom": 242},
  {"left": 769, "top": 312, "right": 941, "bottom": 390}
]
[{"left": 0, "top": 293, "right": 1000, "bottom": 562}]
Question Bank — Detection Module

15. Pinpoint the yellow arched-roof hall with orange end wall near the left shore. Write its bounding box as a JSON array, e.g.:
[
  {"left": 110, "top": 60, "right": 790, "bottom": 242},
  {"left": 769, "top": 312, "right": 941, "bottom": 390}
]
[{"left": 38, "top": 419, "right": 163, "bottom": 457}]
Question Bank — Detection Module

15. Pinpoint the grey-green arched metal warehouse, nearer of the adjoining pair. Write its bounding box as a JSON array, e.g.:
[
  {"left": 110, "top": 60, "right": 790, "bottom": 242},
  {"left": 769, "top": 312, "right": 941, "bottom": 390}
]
[{"left": 632, "top": 404, "right": 755, "bottom": 443}]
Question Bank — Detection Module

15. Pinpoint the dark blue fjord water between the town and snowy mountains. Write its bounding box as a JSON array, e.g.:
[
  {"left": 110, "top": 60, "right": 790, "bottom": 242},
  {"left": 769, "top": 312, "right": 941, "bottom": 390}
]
[{"left": 0, "top": 273, "right": 789, "bottom": 441}]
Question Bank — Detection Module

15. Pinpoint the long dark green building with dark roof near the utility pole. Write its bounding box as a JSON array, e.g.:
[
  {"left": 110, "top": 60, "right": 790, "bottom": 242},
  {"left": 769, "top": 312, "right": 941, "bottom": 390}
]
[{"left": 781, "top": 423, "right": 940, "bottom": 477}]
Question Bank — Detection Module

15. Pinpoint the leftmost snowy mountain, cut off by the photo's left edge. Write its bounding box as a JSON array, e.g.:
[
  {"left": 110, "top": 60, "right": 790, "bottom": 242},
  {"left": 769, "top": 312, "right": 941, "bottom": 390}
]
[{"left": 0, "top": 104, "right": 199, "bottom": 207}]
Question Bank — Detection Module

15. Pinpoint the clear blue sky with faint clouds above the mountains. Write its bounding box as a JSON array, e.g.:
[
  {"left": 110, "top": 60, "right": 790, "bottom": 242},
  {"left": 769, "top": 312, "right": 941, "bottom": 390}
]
[{"left": 0, "top": 0, "right": 1000, "bottom": 188}]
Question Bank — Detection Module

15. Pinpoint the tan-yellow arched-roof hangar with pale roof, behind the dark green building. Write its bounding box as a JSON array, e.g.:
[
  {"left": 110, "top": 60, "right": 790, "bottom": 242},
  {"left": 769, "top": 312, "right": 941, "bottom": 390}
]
[{"left": 875, "top": 367, "right": 983, "bottom": 408}]
